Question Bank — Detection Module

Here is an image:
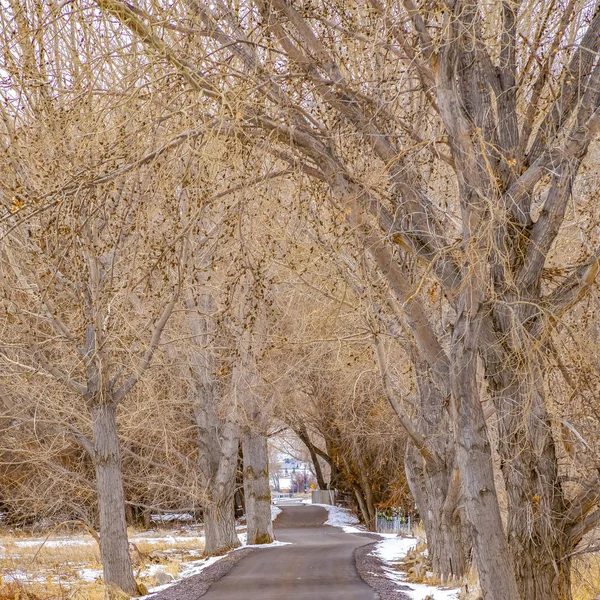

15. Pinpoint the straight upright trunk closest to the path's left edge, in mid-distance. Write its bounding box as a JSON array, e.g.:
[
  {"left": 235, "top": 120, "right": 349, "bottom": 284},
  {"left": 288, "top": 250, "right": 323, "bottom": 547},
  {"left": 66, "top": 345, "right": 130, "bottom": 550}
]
[{"left": 242, "top": 431, "right": 275, "bottom": 545}]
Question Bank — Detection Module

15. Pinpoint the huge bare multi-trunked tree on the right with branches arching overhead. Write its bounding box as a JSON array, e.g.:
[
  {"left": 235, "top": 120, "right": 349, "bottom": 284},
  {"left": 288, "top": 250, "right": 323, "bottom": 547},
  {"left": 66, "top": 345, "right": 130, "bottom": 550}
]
[{"left": 41, "top": 0, "right": 600, "bottom": 600}]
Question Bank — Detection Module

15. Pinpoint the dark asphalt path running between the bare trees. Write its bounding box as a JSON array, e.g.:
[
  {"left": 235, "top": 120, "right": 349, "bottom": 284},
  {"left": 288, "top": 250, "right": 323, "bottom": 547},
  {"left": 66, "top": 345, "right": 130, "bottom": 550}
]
[{"left": 203, "top": 503, "right": 375, "bottom": 600}]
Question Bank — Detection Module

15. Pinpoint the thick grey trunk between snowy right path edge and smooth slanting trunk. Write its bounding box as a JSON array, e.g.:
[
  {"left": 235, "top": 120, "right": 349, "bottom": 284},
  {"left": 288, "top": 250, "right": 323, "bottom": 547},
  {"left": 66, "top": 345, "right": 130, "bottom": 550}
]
[{"left": 405, "top": 446, "right": 469, "bottom": 582}]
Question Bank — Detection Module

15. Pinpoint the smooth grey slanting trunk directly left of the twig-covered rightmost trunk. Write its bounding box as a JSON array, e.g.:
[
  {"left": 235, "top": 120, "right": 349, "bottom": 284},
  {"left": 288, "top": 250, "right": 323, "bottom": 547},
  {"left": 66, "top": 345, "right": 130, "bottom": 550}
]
[{"left": 450, "top": 313, "right": 529, "bottom": 600}]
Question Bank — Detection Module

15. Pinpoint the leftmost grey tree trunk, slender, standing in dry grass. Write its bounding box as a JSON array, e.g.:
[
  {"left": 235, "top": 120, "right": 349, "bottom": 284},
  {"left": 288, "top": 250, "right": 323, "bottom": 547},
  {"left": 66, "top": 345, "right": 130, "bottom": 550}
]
[{"left": 92, "top": 403, "right": 139, "bottom": 596}]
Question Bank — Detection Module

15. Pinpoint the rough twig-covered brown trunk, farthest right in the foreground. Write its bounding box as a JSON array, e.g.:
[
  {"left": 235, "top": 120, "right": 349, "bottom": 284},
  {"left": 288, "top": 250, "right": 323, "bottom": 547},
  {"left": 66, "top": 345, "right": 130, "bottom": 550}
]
[{"left": 488, "top": 357, "right": 572, "bottom": 600}]
